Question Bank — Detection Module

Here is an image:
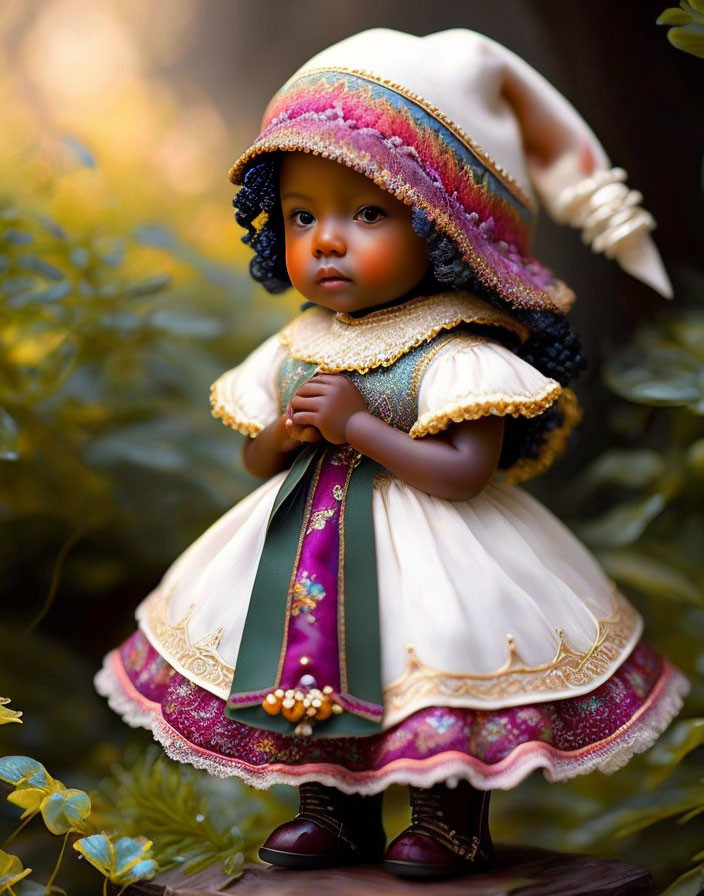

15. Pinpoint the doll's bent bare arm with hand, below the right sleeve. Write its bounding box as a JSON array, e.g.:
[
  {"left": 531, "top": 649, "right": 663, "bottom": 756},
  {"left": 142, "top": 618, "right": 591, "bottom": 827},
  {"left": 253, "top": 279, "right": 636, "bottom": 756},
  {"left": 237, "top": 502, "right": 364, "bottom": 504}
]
[{"left": 286, "top": 374, "right": 503, "bottom": 501}]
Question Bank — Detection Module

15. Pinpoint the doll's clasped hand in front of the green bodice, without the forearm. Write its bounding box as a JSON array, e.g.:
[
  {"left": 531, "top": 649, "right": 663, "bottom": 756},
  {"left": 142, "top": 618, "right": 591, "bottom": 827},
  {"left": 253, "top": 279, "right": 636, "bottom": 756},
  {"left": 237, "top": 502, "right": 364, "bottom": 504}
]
[{"left": 290, "top": 373, "right": 367, "bottom": 445}]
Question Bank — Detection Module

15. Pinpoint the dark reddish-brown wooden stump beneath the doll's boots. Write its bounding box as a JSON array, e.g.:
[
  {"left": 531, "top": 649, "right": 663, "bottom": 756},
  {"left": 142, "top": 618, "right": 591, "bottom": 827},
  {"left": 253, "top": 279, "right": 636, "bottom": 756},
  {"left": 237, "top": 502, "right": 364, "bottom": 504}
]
[{"left": 125, "top": 846, "right": 653, "bottom": 896}]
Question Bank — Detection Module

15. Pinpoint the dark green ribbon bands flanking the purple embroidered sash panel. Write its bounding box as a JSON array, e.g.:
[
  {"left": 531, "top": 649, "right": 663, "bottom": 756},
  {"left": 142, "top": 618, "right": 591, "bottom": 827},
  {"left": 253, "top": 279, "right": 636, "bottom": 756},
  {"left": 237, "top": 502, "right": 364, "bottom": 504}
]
[{"left": 225, "top": 442, "right": 383, "bottom": 737}]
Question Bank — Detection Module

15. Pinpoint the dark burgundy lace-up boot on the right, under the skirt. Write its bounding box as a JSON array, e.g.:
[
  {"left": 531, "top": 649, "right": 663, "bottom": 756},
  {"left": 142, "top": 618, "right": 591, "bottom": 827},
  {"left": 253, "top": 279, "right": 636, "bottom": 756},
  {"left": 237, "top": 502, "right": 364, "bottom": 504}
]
[{"left": 382, "top": 781, "right": 494, "bottom": 879}]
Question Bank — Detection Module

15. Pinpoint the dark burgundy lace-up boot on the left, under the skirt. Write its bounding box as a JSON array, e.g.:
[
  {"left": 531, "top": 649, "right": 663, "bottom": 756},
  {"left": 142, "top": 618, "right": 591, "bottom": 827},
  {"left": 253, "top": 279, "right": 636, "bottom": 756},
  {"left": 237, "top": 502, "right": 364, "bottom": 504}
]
[{"left": 259, "top": 782, "right": 386, "bottom": 868}]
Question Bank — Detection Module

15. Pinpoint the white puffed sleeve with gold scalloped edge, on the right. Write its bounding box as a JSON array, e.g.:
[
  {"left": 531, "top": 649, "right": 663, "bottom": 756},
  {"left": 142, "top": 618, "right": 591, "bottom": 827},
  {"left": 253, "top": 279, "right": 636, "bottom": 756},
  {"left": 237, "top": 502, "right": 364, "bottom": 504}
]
[{"left": 410, "top": 334, "right": 562, "bottom": 438}]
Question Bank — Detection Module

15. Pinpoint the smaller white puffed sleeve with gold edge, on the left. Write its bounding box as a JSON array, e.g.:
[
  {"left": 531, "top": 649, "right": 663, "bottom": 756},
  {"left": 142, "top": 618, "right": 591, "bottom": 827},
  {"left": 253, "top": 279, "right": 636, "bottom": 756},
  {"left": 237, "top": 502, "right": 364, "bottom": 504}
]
[{"left": 210, "top": 335, "right": 286, "bottom": 437}]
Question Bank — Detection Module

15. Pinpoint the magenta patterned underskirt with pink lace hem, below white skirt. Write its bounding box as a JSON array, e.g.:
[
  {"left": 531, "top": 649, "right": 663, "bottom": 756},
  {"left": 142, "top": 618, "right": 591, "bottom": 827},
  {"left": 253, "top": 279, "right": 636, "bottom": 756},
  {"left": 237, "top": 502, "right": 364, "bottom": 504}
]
[{"left": 96, "top": 631, "right": 688, "bottom": 794}]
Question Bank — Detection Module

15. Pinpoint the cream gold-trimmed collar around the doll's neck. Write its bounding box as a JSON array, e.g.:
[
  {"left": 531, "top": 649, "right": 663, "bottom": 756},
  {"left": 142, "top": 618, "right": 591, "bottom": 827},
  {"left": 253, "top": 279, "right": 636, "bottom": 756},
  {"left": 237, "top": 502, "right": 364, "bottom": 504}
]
[{"left": 279, "top": 292, "right": 527, "bottom": 373}]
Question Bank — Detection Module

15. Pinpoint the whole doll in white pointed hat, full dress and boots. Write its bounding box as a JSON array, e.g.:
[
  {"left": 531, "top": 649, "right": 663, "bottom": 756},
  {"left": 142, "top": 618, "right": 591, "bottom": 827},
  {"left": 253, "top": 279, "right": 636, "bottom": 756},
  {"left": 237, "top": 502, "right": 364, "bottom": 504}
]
[{"left": 96, "top": 30, "right": 687, "bottom": 878}]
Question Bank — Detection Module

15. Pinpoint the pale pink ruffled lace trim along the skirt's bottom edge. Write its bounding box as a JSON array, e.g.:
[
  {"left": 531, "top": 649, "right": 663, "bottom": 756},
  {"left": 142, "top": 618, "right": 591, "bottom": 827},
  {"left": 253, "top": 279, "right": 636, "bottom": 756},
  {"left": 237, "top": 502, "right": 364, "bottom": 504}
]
[{"left": 96, "top": 654, "right": 689, "bottom": 796}]
